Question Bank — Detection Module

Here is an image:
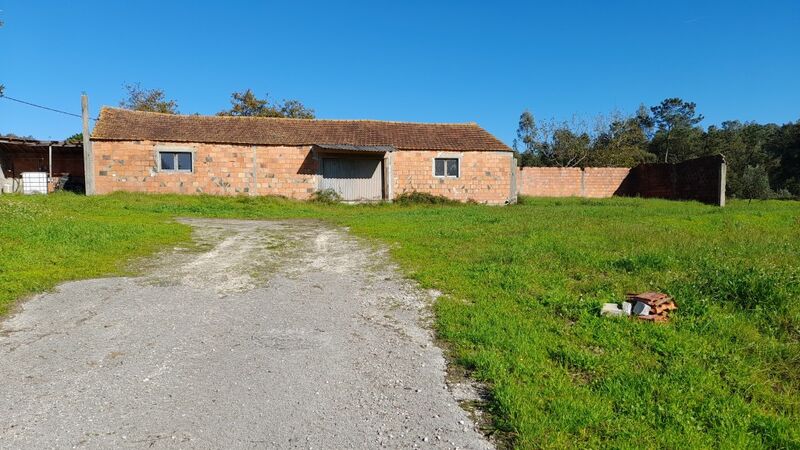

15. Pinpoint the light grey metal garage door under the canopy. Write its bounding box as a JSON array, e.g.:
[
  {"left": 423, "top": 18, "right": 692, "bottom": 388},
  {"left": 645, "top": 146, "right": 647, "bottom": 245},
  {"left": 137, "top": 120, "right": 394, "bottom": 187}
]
[{"left": 320, "top": 158, "right": 383, "bottom": 201}]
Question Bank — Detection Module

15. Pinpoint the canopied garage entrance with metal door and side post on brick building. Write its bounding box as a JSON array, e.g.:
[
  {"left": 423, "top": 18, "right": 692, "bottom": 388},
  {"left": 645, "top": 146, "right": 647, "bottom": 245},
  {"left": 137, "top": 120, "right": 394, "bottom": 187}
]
[{"left": 314, "top": 144, "right": 396, "bottom": 202}]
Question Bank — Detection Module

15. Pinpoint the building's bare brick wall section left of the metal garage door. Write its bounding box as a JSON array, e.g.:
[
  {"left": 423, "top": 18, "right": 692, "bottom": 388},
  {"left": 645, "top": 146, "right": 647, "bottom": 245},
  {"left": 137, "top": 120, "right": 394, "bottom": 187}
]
[{"left": 92, "top": 141, "right": 318, "bottom": 199}]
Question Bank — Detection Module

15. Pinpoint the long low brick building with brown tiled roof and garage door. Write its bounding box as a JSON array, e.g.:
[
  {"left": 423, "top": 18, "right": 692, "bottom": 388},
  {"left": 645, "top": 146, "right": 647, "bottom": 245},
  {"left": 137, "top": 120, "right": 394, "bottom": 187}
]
[{"left": 91, "top": 108, "right": 517, "bottom": 204}]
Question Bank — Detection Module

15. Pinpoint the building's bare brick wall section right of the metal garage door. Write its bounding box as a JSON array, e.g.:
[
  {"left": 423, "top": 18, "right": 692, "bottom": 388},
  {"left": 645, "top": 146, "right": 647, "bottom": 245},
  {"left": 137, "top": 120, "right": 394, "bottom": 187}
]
[{"left": 391, "top": 150, "right": 515, "bottom": 204}]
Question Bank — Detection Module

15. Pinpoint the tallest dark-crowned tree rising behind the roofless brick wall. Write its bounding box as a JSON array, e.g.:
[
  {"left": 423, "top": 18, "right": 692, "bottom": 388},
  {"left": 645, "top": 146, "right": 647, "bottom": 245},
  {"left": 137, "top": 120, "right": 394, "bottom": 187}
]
[{"left": 650, "top": 98, "right": 703, "bottom": 162}]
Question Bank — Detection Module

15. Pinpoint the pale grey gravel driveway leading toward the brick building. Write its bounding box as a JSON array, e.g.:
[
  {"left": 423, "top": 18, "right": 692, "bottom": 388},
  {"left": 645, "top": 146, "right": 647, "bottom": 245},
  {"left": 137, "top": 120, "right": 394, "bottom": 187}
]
[{"left": 0, "top": 220, "right": 490, "bottom": 448}]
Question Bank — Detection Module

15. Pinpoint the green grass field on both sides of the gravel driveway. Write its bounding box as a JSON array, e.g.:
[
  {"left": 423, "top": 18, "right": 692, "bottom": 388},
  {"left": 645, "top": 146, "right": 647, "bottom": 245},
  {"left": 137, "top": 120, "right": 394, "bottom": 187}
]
[{"left": 0, "top": 195, "right": 800, "bottom": 448}]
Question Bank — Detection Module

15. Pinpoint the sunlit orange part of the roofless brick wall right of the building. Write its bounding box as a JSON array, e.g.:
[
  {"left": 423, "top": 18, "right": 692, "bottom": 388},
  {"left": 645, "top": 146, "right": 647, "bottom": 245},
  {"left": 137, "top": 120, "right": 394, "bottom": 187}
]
[{"left": 517, "top": 167, "right": 630, "bottom": 198}]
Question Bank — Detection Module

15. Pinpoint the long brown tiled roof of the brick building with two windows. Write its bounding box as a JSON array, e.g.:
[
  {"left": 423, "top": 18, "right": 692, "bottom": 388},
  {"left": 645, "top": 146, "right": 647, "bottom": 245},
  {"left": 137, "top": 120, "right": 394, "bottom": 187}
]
[{"left": 92, "top": 107, "right": 511, "bottom": 151}]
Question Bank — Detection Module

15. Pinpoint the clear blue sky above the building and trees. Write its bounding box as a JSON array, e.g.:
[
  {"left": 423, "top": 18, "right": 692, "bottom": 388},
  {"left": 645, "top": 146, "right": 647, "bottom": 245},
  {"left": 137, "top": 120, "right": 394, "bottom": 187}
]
[{"left": 0, "top": 0, "right": 800, "bottom": 144}]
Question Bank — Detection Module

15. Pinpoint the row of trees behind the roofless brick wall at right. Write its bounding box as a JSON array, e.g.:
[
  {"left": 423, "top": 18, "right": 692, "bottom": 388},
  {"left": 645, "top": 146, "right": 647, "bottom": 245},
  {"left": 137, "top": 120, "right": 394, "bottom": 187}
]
[{"left": 513, "top": 98, "right": 800, "bottom": 198}]
